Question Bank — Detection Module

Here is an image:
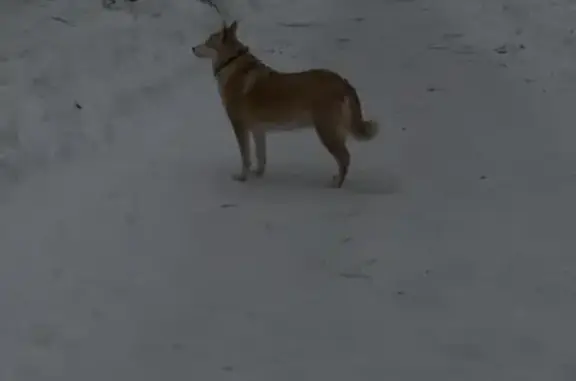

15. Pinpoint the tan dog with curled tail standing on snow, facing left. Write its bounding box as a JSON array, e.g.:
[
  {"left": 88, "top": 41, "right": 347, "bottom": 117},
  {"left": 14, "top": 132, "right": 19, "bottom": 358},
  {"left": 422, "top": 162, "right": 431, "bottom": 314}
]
[{"left": 192, "top": 21, "right": 378, "bottom": 188}]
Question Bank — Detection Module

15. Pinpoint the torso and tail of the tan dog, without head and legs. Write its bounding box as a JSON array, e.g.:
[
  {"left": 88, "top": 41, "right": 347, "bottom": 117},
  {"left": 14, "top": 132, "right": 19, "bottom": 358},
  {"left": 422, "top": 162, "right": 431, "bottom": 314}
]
[{"left": 221, "top": 62, "right": 376, "bottom": 140}]
